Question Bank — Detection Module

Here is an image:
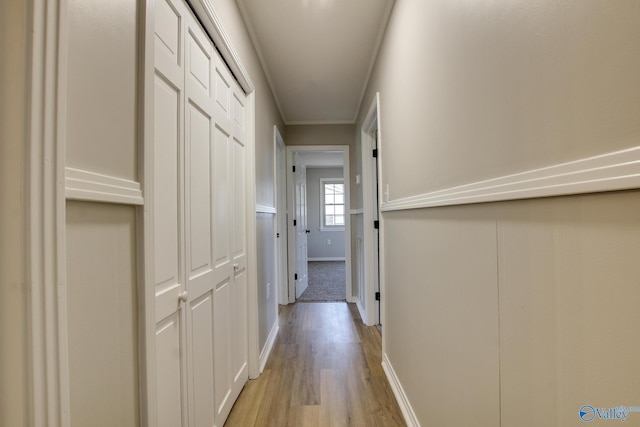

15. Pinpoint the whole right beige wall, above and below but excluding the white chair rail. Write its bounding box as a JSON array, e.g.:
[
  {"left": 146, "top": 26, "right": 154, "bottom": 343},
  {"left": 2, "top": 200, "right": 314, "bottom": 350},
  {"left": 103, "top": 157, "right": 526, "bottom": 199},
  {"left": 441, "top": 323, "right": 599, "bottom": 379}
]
[{"left": 356, "top": 0, "right": 640, "bottom": 427}]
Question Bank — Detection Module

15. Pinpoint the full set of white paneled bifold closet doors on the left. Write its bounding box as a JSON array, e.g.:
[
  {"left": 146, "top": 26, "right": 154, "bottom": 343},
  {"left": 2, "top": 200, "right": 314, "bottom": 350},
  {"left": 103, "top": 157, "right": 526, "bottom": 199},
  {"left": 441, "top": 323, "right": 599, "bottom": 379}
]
[{"left": 151, "top": 0, "right": 248, "bottom": 426}]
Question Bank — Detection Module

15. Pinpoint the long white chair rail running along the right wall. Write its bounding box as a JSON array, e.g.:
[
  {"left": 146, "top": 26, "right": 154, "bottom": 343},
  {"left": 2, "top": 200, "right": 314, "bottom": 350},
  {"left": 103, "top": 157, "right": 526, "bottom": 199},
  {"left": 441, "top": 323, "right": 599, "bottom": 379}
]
[{"left": 381, "top": 146, "right": 640, "bottom": 212}]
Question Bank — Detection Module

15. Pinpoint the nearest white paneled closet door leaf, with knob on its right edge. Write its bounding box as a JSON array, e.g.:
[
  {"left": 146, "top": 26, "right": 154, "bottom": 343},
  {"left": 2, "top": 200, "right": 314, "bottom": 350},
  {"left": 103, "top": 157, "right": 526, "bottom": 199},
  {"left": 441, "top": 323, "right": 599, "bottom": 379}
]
[{"left": 154, "top": 0, "right": 188, "bottom": 427}]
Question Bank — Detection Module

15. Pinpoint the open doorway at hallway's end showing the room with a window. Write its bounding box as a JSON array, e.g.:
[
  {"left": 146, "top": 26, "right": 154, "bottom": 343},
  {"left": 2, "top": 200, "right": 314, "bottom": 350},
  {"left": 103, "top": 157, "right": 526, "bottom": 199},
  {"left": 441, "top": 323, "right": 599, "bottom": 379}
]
[{"left": 287, "top": 146, "right": 352, "bottom": 302}]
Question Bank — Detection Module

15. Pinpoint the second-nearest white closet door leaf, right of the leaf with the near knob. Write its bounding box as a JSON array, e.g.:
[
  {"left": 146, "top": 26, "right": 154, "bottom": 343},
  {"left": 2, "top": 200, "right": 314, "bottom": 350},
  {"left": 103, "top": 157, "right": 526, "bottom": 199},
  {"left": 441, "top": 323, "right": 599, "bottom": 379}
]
[{"left": 184, "top": 16, "right": 216, "bottom": 426}]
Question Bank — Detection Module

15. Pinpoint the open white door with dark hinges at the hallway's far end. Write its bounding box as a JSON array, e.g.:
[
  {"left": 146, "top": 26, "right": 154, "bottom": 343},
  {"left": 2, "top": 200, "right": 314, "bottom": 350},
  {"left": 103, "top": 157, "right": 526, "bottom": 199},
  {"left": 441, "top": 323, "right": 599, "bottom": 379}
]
[{"left": 294, "top": 154, "right": 309, "bottom": 299}]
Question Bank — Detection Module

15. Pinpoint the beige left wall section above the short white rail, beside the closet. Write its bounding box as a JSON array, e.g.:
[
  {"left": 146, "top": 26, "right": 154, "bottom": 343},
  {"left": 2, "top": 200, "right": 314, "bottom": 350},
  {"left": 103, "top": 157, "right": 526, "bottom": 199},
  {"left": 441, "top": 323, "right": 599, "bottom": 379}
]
[{"left": 65, "top": 0, "right": 138, "bottom": 181}]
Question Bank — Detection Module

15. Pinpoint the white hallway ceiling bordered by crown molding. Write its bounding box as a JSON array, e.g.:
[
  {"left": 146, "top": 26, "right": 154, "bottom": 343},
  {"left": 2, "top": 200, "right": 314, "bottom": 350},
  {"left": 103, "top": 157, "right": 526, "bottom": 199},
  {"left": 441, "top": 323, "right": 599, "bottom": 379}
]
[{"left": 236, "top": 0, "right": 393, "bottom": 124}]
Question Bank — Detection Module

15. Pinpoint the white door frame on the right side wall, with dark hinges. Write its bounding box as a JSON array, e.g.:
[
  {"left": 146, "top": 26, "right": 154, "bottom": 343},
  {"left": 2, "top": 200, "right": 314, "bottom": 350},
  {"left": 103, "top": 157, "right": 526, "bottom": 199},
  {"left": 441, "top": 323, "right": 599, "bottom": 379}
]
[{"left": 360, "top": 93, "right": 384, "bottom": 325}]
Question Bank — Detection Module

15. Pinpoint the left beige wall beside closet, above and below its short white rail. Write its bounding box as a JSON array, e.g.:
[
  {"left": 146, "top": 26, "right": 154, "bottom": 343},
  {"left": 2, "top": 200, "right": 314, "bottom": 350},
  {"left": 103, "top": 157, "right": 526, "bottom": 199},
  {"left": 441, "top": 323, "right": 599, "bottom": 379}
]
[{"left": 61, "top": 0, "right": 140, "bottom": 426}]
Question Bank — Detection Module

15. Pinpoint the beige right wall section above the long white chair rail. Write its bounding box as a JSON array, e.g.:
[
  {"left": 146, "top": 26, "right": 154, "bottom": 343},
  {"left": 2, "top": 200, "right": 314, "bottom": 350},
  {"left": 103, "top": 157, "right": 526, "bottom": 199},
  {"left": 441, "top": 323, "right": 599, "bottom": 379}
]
[{"left": 361, "top": 0, "right": 640, "bottom": 199}]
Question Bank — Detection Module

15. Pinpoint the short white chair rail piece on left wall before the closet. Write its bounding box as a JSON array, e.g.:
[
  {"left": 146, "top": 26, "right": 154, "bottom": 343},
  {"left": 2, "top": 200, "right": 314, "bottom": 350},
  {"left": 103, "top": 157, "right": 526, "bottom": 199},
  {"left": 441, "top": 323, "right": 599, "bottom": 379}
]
[{"left": 65, "top": 167, "right": 144, "bottom": 205}]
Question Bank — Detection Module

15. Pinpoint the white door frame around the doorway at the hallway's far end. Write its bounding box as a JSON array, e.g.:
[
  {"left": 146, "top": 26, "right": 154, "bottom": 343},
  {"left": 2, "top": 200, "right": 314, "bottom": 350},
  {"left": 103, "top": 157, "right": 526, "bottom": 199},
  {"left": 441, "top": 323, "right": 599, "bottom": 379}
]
[{"left": 287, "top": 145, "right": 355, "bottom": 303}]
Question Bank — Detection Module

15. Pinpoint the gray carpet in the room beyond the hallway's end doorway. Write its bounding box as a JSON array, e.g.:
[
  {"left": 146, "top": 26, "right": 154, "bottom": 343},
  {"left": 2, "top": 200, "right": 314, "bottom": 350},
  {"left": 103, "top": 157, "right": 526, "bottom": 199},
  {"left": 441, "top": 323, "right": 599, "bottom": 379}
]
[{"left": 298, "top": 261, "right": 347, "bottom": 301}]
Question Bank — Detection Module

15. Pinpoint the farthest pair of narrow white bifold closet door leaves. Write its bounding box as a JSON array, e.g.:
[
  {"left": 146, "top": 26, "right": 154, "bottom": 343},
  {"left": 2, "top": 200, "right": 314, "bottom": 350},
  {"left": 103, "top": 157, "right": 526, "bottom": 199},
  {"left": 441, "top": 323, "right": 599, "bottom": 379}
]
[{"left": 213, "top": 41, "right": 248, "bottom": 419}]
